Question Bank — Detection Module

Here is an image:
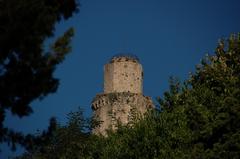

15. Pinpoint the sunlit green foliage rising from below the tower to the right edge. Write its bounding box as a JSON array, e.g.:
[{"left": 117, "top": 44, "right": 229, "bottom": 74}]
[{"left": 17, "top": 35, "right": 240, "bottom": 159}]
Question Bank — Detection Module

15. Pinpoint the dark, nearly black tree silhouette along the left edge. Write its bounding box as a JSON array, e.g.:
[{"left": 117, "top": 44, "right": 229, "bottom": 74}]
[{"left": 0, "top": 0, "right": 78, "bottom": 148}]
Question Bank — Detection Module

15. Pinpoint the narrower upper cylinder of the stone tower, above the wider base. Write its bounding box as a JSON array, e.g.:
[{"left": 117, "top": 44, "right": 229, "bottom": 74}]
[{"left": 104, "top": 57, "right": 143, "bottom": 93}]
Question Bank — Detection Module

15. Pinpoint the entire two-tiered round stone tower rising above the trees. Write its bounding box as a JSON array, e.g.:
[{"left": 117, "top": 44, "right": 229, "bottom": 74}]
[{"left": 92, "top": 55, "right": 153, "bottom": 135}]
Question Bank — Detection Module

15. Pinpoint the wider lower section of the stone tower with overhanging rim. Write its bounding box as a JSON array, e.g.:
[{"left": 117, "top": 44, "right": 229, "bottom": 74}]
[{"left": 92, "top": 92, "right": 153, "bottom": 135}]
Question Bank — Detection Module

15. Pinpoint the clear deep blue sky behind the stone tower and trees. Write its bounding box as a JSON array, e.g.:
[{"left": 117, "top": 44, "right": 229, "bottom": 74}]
[{"left": 0, "top": 0, "right": 240, "bottom": 159}]
